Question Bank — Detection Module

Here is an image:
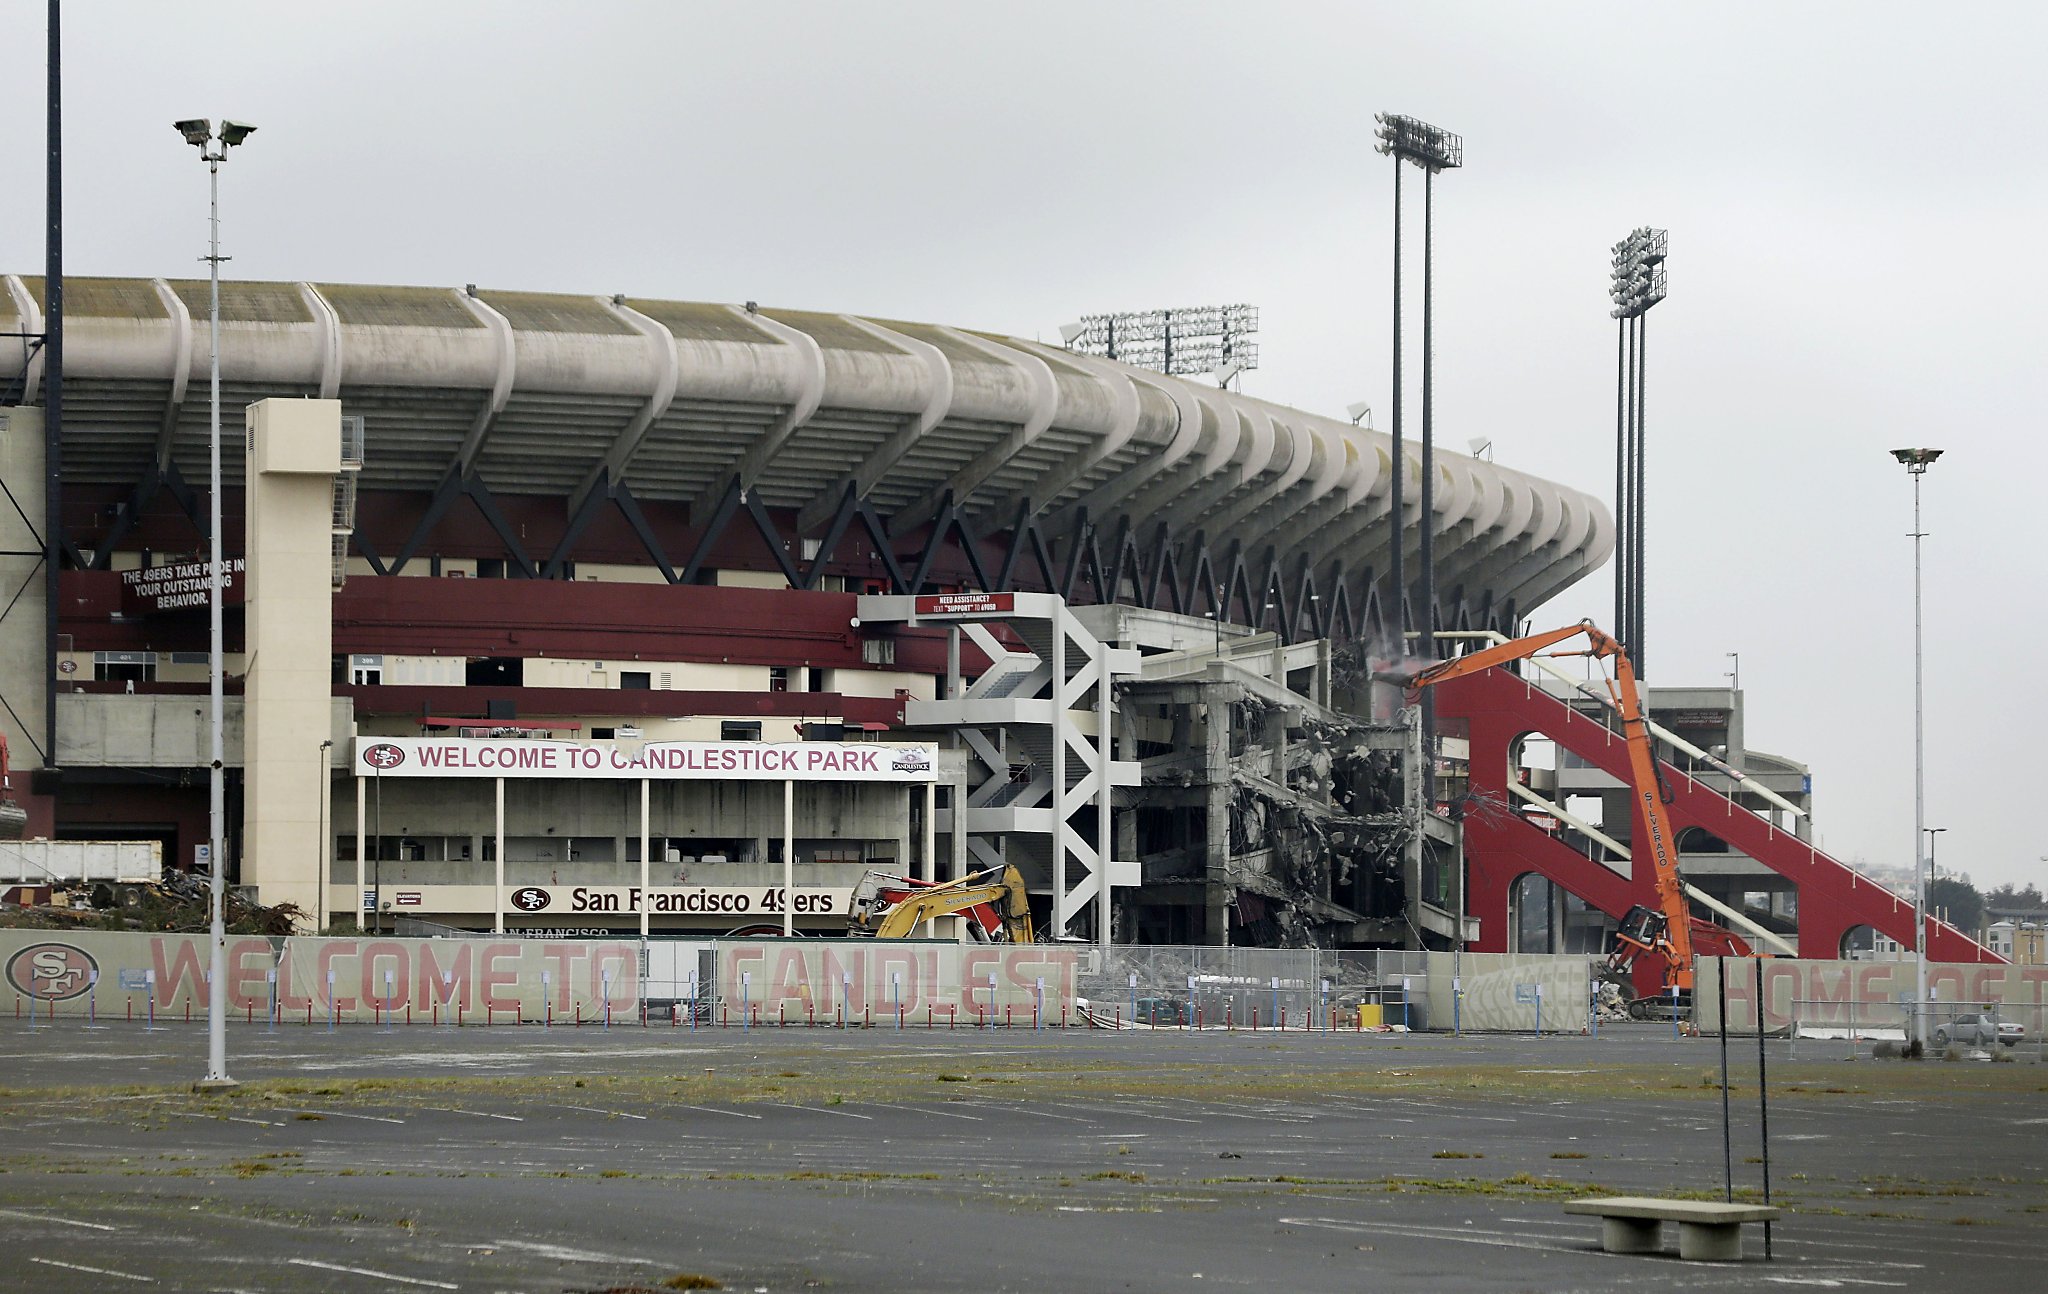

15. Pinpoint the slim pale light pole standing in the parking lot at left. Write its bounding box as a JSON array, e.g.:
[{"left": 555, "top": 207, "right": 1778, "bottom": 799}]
[{"left": 174, "top": 119, "right": 256, "bottom": 1091}]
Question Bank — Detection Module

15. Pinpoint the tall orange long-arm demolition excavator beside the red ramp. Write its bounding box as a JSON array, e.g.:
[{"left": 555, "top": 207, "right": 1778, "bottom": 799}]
[{"left": 1405, "top": 620, "right": 1712, "bottom": 997}]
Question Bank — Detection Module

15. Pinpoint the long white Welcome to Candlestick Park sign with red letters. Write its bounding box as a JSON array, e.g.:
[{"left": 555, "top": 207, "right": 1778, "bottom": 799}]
[{"left": 356, "top": 737, "right": 936, "bottom": 782}]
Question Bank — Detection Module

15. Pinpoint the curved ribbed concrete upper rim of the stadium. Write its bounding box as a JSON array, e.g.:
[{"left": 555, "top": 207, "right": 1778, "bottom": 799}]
[{"left": 0, "top": 274, "right": 1614, "bottom": 612}]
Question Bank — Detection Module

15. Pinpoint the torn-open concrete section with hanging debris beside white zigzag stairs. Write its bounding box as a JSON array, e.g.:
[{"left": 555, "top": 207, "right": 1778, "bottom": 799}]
[{"left": 1118, "top": 612, "right": 1423, "bottom": 948}]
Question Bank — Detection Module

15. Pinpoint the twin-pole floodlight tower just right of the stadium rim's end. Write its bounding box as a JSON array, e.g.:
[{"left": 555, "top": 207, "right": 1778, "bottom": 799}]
[{"left": 1608, "top": 225, "right": 1671, "bottom": 678}]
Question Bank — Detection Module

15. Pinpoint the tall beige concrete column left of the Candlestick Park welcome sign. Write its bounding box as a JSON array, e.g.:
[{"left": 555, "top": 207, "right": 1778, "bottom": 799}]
[{"left": 239, "top": 399, "right": 342, "bottom": 915}]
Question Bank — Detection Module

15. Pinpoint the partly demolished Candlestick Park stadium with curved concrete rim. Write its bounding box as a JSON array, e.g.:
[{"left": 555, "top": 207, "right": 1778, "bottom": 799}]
[{"left": 0, "top": 276, "right": 1982, "bottom": 954}]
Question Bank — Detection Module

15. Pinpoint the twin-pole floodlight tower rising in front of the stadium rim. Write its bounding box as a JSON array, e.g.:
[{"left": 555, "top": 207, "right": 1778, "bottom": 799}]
[{"left": 1372, "top": 113, "right": 1464, "bottom": 655}]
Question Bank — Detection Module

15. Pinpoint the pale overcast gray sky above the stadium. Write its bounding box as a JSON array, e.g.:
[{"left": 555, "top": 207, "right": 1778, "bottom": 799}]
[{"left": 12, "top": 0, "right": 2048, "bottom": 900}]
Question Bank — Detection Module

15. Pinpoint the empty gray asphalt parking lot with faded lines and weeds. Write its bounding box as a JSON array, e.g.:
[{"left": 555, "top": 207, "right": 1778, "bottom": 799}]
[{"left": 0, "top": 1020, "right": 2048, "bottom": 1294}]
